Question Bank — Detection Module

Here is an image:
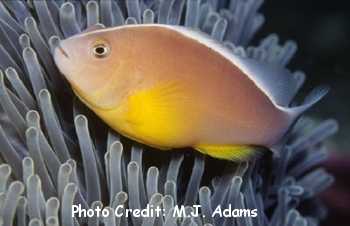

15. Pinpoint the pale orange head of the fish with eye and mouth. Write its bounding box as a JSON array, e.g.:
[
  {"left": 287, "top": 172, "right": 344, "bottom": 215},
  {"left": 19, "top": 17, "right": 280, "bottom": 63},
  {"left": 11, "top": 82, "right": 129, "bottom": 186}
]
[{"left": 54, "top": 29, "right": 139, "bottom": 109}]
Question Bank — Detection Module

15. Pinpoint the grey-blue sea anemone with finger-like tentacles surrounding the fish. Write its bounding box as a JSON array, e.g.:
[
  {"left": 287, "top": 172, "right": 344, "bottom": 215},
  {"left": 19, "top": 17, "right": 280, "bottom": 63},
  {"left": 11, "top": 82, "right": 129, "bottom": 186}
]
[{"left": 0, "top": 0, "right": 337, "bottom": 226}]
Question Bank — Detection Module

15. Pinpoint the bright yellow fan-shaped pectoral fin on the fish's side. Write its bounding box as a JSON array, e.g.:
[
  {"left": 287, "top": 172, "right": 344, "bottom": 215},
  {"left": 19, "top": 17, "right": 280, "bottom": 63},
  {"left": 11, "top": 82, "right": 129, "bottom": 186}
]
[{"left": 124, "top": 80, "right": 199, "bottom": 148}]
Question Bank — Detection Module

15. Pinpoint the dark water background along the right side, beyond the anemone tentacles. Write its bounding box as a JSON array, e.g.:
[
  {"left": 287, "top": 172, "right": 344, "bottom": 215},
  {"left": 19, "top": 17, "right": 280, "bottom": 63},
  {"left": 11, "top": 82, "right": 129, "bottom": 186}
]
[{"left": 254, "top": 0, "right": 350, "bottom": 225}]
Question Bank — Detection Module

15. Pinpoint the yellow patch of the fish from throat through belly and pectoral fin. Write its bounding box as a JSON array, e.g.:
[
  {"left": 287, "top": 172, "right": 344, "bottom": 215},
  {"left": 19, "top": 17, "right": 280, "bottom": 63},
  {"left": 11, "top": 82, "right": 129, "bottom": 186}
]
[{"left": 92, "top": 79, "right": 196, "bottom": 148}]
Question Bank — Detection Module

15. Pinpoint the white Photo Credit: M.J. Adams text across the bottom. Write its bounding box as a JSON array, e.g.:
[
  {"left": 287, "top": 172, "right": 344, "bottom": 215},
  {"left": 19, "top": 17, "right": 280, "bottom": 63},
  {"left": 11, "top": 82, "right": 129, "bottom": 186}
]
[{"left": 72, "top": 204, "right": 258, "bottom": 218}]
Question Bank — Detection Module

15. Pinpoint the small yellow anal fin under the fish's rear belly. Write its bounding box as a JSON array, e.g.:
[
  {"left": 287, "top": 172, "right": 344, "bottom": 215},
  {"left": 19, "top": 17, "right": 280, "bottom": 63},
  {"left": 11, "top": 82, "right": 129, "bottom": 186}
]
[{"left": 194, "top": 145, "right": 266, "bottom": 162}]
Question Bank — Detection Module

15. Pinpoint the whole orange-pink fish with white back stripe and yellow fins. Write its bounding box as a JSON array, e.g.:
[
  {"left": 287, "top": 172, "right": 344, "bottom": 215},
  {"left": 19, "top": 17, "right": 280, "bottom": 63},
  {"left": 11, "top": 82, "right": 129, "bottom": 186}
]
[{"left": 53, "top": 24, "right": 328, "bottom": 162}]
